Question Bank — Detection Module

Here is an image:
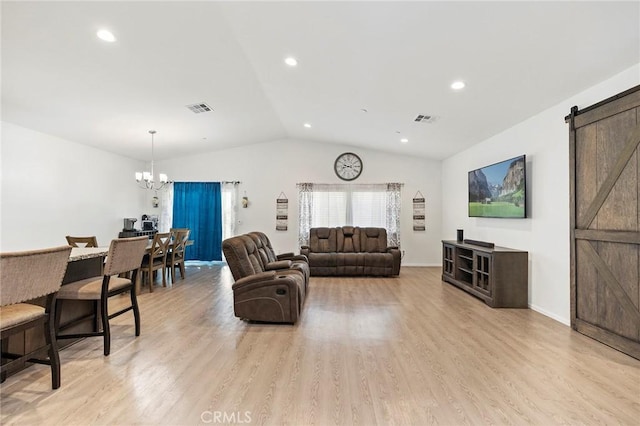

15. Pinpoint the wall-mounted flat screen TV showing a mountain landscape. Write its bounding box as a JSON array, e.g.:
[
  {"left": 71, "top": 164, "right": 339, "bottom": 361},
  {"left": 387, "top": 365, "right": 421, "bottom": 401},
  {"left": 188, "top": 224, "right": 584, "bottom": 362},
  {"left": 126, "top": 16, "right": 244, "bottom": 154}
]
[{"left": 469, "top": 155, "right": 527, "bottom": 218}]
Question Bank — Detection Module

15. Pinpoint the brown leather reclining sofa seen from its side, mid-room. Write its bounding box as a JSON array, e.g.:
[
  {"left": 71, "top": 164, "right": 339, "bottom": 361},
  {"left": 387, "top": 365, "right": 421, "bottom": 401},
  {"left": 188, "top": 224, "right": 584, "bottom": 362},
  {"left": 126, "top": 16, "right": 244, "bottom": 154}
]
[{"left": 222, "top": 232, "right": 309, "bottom": 324}]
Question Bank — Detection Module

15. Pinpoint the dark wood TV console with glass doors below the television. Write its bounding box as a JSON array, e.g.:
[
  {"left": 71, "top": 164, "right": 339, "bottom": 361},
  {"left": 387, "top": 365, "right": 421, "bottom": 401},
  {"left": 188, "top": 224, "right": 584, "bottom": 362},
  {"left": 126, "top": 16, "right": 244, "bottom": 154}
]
[{"left": 442, "top": 241, "right": 529, "bottom": 308}]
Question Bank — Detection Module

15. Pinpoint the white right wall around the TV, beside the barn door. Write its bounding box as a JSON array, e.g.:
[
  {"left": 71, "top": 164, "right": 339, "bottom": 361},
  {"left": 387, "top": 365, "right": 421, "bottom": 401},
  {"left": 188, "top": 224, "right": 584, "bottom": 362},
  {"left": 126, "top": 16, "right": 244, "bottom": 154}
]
[{"left": 442, "top": 65, "right": 640, "bottom": 324}]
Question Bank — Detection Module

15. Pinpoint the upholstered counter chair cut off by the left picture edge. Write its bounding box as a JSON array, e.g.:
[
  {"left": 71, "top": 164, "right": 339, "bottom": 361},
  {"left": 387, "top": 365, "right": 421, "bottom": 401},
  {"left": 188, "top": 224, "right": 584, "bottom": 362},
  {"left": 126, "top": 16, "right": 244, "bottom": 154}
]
[{"left": 0, "top": 246, "right": 71, "bottom": 389}]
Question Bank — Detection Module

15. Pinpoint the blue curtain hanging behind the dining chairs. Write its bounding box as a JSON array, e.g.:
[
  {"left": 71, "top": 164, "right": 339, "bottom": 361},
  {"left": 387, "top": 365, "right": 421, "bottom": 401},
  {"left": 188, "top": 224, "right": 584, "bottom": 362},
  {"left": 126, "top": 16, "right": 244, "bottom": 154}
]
[{"left": 173, "top": 182, "right": 222, "bottom": 261}]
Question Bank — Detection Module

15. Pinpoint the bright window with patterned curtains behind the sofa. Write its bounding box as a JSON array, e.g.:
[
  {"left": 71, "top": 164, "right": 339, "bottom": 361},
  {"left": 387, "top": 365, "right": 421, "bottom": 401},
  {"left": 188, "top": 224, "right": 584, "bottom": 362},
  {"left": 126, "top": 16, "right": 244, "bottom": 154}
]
[{"left": 298, "top": 183, "right": 402, "bottom": 247}]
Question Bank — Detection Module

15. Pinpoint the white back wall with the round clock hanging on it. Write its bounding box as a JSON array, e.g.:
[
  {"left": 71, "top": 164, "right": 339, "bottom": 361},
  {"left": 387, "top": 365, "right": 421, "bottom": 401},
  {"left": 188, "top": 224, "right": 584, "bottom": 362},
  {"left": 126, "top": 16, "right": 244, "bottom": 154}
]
[{"left": 157, "top": 140, "right": 441, "bottom": 265}]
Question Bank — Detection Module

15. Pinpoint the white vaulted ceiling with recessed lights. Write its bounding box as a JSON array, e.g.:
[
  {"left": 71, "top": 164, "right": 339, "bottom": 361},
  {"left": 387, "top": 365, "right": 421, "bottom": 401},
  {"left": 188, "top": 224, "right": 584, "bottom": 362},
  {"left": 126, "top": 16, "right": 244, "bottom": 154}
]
[{"left": 2, "top": 1, "right": 640, "bottom": 160}]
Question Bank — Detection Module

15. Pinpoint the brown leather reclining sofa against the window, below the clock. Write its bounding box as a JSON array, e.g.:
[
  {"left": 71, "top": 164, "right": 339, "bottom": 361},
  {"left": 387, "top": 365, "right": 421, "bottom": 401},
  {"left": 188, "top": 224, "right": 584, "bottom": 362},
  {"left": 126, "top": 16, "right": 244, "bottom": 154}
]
[{"left": 300, "top": 226, "right": 401, "bottom": 276}]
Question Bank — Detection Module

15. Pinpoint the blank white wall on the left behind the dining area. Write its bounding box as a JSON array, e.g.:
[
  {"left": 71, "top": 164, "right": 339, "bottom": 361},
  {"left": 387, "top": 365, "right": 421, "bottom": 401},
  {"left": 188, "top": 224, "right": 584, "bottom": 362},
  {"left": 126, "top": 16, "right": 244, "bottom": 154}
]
[{"left": 0, "top": 122, "right": 146, "bottom": 251}]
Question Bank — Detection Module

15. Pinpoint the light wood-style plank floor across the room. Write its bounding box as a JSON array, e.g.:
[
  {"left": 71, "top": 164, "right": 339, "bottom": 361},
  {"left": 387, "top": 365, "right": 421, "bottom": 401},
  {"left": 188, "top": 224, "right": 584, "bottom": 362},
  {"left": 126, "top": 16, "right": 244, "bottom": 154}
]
[{"left": 0, "top": 266, "right": 640, "bottom": 425}]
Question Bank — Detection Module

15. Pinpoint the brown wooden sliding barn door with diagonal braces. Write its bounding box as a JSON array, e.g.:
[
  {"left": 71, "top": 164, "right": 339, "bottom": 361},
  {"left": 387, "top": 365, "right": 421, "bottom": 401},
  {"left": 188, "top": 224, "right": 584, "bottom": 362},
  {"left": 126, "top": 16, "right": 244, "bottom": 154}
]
[{"left": 567, "top": 86, "right": 640, "bottom": 359}]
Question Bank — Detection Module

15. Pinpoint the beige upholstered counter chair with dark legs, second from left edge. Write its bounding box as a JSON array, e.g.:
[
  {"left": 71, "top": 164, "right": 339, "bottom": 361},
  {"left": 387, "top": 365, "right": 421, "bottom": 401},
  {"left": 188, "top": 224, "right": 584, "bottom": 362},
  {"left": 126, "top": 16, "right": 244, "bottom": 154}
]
[{"left": 56, "top": 236, "right": 149, "bottom": 356}]
